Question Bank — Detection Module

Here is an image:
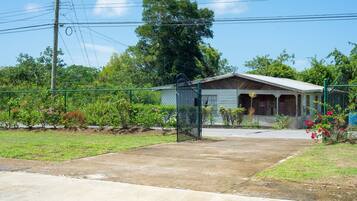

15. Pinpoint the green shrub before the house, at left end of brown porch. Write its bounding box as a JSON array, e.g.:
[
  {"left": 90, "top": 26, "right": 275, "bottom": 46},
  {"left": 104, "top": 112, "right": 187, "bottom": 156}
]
[{"left": 219, "top": 106, "right": 245, "bottom": 127}]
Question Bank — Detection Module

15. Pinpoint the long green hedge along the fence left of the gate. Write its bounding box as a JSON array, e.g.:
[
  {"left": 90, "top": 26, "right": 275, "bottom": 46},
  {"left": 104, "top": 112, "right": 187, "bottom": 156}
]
[{"left": 0, "top": 94, "right": 176, "bottom": 128}]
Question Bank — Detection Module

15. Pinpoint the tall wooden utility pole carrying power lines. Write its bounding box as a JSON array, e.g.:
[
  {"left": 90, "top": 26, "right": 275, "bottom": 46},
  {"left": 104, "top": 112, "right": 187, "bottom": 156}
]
[{"left": 51, "top": 0, "right": 60, "bottom": 92}]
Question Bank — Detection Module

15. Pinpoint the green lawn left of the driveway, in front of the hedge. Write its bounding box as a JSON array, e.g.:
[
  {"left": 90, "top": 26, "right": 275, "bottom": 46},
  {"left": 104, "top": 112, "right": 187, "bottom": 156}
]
[{"left": 0, "top": 131, "right": 175, "bottom": 161}]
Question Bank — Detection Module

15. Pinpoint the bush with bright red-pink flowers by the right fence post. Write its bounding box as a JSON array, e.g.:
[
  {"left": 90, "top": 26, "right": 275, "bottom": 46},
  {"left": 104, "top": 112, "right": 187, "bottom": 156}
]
[{"left": 305, "top": 106, "right": 351, "bottom": 144}]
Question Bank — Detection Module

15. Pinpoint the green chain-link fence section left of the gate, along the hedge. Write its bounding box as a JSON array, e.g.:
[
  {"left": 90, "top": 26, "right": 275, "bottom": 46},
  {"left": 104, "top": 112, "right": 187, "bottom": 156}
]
[{"left": 0, "top": 89, "right": 176, "bottom": 128}]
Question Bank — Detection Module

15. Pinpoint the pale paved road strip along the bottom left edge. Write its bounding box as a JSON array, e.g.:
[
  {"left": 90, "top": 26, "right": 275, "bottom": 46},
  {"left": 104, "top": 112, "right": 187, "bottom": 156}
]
[{"left": 0, "top": 172, "right": 286, "bottom": 201}]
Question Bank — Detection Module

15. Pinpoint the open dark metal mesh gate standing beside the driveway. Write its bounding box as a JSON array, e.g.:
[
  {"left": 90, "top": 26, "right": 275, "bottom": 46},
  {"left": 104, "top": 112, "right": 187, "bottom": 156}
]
[{"left": 176, "top": 74, "right": 202, "bottom": 142}]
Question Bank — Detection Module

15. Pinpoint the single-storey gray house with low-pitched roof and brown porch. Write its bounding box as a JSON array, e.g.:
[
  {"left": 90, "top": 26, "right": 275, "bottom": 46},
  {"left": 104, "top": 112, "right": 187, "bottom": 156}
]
[{"left": 155, "top": 73, "right": 323, "bottom": 128}]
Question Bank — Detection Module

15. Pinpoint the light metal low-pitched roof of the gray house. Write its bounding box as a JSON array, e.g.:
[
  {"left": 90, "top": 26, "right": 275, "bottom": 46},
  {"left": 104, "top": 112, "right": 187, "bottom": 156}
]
[{"left": 153, "top": 73, "right": 323, "bottom": 93}]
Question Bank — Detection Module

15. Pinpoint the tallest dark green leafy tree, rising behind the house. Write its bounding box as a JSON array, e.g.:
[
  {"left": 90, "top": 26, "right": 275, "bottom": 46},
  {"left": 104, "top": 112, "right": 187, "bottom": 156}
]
[{"left": 136, "top": 0, "right": 214, "bottom": 84}]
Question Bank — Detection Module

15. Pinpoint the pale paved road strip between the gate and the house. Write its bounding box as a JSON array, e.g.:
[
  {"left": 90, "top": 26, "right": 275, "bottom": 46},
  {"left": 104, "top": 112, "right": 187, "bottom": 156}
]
[{"left": 202, "top": 128, "right": 310, "bottom": 139}]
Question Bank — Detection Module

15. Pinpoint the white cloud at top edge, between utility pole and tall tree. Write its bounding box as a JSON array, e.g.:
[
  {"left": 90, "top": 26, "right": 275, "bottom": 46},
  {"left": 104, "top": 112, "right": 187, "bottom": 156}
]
[{"left": 93, "top": 0, "right": 128, "bottom": 16}]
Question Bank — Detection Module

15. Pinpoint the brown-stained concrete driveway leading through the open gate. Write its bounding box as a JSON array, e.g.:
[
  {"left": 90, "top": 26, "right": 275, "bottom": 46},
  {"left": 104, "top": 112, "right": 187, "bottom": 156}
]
[{"left": 0, "top": 138, "right": 310, "bottom": 196}]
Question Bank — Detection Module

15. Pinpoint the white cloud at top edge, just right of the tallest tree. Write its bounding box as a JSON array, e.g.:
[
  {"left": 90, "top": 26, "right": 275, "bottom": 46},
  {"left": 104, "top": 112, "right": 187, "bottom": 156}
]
[{"left": 209, "top": 0, "right": 248, "bottom": 15}]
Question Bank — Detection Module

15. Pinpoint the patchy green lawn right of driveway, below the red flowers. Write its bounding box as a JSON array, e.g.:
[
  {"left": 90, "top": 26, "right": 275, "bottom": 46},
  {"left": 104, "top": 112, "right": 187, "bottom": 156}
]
[{"left": 257, "top": 144, "right": 357, "bottom": 182}]
